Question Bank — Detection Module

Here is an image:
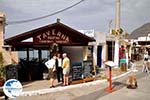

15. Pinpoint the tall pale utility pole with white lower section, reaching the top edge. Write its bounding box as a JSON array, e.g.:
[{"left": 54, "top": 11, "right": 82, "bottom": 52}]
[{"left": 114, "top": 0, "right": 120, "bottom": 66}]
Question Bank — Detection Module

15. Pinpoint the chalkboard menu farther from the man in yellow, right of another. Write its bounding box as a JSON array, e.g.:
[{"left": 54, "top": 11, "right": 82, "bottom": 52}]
[{"left": 83, "top": 60, "right": 93, "bottom": 78}]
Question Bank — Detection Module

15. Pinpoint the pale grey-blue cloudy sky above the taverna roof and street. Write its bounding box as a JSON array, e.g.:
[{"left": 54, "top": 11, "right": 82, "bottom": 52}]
[{"left": 0, "top": 0, "right": 150, "bottom": 38}]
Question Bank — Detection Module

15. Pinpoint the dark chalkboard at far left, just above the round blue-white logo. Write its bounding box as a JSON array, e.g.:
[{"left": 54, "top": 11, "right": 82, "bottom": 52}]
[{"left": 6, "top": 64, "right": 18, "bottom": 80}]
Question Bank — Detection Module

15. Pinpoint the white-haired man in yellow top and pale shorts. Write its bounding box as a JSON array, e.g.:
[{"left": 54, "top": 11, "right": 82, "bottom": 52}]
[{"left": 62, "top": 53, "right": 70, "bottom": 86}]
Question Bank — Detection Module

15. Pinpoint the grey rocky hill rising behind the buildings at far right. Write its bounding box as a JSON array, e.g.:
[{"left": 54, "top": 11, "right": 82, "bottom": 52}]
[{"left": 128, "top": 23, "right": 150, "bottom": 39}]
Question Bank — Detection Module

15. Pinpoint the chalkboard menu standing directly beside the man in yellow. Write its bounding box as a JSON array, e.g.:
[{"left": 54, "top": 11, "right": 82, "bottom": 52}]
[{"left": 72, "top": 62, "right": 82, "bottom": 81}]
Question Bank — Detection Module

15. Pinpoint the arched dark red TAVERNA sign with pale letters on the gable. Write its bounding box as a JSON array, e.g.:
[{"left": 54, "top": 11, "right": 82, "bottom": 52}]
[{"left": 33, "top": 29, "right": 70, "bottom": 43}]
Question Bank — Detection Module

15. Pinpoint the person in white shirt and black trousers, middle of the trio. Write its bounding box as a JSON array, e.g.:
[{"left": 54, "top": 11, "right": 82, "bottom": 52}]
[{"left": 56, "top": 53, "right": 63, "bottom": 82}]
